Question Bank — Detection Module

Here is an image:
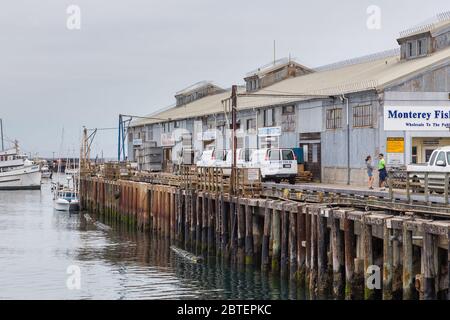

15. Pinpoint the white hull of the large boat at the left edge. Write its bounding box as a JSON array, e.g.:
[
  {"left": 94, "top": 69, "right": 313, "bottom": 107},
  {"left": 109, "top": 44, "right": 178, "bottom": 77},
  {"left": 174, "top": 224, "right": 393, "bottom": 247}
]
[{"left": 0, "top": 166, "right": 42, "bottom": 190}]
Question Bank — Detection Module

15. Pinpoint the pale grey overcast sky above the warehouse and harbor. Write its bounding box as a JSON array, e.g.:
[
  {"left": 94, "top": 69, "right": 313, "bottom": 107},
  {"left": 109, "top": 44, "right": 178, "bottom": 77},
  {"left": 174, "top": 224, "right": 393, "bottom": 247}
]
[{"left": 0, "top": 0, "right": 450, "bottom": 156}]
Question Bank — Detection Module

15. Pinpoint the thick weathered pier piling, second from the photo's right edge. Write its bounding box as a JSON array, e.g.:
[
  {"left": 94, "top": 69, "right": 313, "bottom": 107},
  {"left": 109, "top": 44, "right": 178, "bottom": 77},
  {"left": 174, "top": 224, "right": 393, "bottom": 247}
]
[{"left": 422, "top": 231, "right": 437, "bottom": 300}]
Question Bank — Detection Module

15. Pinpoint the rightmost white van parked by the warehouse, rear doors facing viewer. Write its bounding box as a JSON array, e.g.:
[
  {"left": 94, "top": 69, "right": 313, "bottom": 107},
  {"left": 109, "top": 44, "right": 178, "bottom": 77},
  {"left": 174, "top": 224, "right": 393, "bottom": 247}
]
[{"left": 249, "top": 148, "right": 297, "bottom": 184}]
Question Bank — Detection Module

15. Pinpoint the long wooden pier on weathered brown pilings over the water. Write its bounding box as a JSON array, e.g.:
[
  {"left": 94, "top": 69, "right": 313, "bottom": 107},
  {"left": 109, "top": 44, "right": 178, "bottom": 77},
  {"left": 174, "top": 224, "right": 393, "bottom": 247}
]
[{"left": 80, "top": 175, "right": 450, "bottom": 300}]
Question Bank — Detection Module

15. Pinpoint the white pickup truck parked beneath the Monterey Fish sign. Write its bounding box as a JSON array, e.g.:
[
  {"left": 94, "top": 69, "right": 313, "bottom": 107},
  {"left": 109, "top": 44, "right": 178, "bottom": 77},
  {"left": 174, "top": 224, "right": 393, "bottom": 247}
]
[{"left": 406, "top": 146, "right": 450, "bottom": 193}]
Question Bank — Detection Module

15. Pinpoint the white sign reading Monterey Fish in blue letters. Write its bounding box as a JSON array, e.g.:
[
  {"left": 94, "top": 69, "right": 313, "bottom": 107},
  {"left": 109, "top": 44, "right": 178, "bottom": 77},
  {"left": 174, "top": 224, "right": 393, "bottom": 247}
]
[{"left": 384, "top": 106, "right": 450, "bottom": 131}]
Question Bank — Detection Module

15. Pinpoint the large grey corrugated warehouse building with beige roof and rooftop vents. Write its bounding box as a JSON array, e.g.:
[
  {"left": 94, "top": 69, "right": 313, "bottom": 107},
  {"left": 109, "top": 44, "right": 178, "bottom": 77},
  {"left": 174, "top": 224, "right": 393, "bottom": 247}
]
[{"left": 128, "top": 14, "right": 450, "bottom": 185}]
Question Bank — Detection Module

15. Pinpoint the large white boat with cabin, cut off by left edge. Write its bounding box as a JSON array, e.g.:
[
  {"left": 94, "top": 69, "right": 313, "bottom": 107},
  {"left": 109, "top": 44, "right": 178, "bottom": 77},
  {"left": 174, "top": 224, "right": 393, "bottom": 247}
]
[{"left": 0, "top": 143, "right": 42, "bottom": 190}]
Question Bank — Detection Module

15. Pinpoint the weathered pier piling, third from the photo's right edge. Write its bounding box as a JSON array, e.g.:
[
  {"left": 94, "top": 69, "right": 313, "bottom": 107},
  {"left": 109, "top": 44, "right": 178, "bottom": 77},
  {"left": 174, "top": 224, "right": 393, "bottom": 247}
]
[{"left": 402, "top": 223, "right": 416, "bottom": 300}]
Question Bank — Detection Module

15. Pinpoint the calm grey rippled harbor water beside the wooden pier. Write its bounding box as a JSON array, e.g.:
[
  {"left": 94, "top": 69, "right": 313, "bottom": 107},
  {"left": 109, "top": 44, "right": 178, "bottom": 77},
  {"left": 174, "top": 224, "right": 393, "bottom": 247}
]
[{"left": 0, "top": 182, "right": 299, "bottom": 299}]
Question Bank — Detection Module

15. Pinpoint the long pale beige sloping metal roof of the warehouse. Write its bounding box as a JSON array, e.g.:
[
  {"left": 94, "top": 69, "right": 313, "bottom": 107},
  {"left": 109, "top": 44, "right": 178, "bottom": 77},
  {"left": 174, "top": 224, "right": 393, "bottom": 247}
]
[{"left": 132, "top": 48, "right": 450, "bottom": 126}]
